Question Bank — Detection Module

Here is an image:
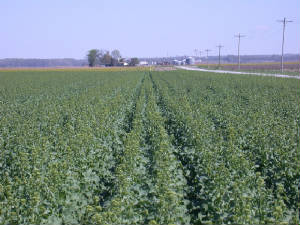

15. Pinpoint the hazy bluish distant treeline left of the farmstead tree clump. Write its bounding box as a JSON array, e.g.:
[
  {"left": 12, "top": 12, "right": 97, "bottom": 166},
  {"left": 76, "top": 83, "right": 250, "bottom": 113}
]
[{"left": 0, "top": 58, "right": 88, "bottom": 67}]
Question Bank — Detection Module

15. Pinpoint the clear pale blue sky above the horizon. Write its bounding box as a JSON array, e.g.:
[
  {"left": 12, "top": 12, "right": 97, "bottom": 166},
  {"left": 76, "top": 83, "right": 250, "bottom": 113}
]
[{"left": 0, "top": 0, "right": 300, "bottom": 58}]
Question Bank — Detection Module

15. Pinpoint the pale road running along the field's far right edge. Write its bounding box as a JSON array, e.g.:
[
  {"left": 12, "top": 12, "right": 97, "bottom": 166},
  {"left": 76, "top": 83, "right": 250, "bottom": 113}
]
[{"left": 177, "top": 66, "right": 300, "bottom": 79}]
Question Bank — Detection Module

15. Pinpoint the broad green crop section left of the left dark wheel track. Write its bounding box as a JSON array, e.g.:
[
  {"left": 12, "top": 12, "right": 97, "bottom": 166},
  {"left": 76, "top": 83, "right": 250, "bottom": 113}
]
[{"left": 0, "top": 71, "right": 141, "bottom": 224}]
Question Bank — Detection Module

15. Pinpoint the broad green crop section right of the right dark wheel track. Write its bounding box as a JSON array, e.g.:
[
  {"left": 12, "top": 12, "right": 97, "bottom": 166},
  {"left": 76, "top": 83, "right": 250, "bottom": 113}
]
[{"left": 151, "top": 71, "right": 299, "bottom": 224}]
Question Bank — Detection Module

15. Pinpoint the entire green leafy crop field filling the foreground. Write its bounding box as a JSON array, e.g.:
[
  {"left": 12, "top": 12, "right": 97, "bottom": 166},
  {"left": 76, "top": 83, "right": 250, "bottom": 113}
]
[{"left": 0, "top": 69, "right": 300, "bottom": 225}]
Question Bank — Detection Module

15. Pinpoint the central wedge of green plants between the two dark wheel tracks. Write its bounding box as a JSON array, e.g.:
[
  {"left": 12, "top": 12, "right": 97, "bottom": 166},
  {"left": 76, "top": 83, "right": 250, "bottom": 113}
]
[{"left": 87, "top": 77, "right": 189, "bottom": 224}]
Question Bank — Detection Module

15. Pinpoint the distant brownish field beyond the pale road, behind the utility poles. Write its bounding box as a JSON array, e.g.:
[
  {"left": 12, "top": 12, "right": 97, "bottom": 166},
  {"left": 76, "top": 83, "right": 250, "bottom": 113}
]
[{"left": 197, "top": 62, "right": 299, "bottom": 75}]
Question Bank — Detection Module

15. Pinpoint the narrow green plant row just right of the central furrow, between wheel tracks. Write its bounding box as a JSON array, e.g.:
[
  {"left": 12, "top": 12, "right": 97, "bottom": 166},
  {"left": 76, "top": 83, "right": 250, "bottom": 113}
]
[{"left": 146, "top": 76, "right": 190, "bottom": 224}]
